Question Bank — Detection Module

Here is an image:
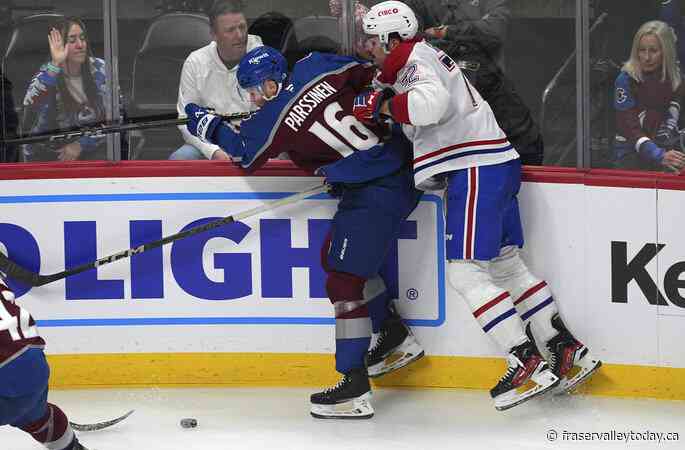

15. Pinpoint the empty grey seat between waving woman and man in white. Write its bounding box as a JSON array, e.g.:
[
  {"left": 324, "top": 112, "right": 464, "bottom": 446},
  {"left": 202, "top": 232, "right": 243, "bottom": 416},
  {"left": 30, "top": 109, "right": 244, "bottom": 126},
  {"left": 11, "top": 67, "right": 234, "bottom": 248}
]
[{"left": 128, "top": 12, "right": 212, "bottom": 159}]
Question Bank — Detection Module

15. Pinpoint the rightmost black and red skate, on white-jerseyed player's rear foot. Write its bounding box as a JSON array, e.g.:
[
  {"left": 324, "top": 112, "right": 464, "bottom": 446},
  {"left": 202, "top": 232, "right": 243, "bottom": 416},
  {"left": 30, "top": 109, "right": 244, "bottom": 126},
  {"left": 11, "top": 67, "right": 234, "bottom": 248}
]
[{"left": 547, "top": 314, "right": 602, "bottom": 394}]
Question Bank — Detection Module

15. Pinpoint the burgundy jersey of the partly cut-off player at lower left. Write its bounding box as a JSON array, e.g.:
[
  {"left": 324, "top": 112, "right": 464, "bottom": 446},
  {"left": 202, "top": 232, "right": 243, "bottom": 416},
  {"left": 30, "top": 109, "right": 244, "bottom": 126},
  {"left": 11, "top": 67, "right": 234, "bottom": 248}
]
[{"left": 0, "top": 298, "right": 45, "bottom": 368}]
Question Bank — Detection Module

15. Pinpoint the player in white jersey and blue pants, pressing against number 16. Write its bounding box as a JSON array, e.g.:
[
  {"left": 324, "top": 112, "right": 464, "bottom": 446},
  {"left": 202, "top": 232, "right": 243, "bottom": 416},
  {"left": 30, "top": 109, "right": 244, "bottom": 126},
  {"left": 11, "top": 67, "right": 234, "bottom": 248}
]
[{"left": 354, "top": 1, "right": 601, "bottom": 410}]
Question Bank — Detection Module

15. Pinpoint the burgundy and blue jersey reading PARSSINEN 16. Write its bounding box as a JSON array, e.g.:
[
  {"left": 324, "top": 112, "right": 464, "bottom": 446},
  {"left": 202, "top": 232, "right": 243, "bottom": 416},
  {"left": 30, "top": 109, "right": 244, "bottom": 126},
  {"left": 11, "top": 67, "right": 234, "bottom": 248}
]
[{"left": 216, "top": 53, "right": 406, "bottom": 182}]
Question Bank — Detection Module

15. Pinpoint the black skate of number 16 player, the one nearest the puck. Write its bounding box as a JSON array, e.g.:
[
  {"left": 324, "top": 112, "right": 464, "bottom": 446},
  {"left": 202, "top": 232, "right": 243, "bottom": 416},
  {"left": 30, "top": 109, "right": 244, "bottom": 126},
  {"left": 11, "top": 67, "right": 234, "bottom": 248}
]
[{"left": 310, "top": 369, "right": 373, "bottom": 419}]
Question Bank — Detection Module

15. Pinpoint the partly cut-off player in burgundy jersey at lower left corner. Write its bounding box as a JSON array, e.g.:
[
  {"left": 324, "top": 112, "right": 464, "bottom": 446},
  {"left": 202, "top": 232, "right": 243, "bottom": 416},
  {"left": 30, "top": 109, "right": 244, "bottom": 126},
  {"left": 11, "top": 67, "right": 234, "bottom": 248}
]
[{"left": 0, "top": 279, "right": 87, "bottom": 450}]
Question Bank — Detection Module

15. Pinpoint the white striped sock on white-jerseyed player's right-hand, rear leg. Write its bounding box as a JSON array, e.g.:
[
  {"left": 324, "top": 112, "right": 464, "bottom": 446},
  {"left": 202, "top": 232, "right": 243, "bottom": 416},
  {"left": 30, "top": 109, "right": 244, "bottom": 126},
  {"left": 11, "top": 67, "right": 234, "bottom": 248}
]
[{"left": 490, "top": 247, "right": 559, "bottom": 344}]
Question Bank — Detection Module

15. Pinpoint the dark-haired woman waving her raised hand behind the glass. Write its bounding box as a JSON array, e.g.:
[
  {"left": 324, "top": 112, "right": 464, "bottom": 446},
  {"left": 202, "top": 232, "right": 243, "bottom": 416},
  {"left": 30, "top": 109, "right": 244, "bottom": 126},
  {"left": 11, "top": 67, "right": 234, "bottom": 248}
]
[{"left": 22, "top": 17, "right": 107, "bottom": 161}]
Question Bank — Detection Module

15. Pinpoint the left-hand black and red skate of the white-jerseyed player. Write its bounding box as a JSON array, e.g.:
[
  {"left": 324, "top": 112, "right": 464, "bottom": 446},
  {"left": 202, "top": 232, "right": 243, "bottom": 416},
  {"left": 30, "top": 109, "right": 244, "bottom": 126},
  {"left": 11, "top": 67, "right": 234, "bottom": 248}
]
[{"left": 490, "top": 324, "right": 559, "bottom": 411}]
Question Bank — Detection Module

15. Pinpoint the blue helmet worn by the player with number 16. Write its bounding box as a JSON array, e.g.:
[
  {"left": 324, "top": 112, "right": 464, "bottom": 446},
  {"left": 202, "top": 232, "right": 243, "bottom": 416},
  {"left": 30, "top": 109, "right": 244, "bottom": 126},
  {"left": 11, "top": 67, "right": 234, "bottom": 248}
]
[{"left": 238, "top": 45, "right": 288, "bottom": 100}]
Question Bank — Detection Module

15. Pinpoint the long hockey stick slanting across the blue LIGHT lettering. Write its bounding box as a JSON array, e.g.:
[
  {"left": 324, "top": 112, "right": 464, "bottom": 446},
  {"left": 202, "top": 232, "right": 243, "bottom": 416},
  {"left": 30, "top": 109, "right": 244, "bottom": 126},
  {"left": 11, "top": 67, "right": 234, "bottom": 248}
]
[{"left": 0, "top": 184, "right": 329, "bottom": 286}]
